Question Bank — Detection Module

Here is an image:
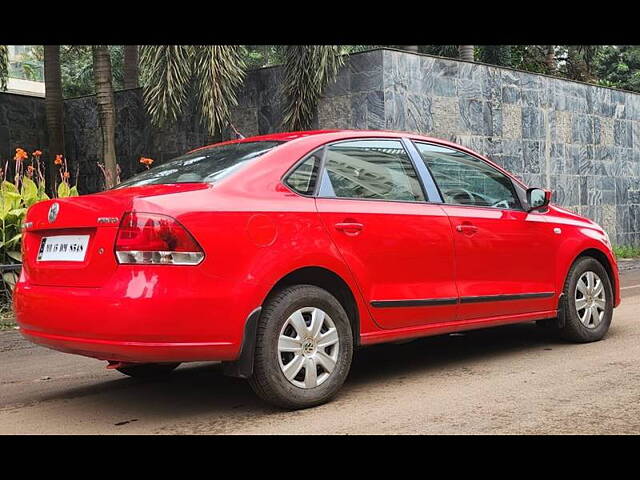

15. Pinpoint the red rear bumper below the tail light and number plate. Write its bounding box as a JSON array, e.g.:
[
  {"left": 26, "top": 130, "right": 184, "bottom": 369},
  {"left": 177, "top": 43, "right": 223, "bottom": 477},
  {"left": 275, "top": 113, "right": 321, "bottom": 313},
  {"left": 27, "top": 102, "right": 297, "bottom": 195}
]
[{"left": 14, "top": 266, "right": 260, "bottom": 362}]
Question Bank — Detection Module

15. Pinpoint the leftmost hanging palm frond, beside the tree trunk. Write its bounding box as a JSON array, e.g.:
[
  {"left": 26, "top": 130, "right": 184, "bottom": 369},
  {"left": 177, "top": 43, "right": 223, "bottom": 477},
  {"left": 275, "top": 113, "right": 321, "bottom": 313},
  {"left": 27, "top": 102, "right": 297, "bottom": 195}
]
[{"left": 140, "top": 45, "right": 194, "bottom": 127}]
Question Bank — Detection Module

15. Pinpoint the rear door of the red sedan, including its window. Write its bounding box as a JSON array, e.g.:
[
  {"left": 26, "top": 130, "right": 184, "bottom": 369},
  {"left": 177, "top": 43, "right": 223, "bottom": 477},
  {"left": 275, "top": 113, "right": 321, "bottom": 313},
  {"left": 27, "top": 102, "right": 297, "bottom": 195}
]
[{"left": 316, "top": 139, "right": 457, "bottom": 329}]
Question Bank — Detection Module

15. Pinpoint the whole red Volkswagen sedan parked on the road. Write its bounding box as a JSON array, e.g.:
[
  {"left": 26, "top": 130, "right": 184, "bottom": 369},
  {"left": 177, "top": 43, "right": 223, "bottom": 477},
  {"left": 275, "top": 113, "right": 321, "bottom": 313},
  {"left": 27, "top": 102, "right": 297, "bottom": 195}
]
[{"left": 14, "top": 131, "right": 620, "bottom": 408}]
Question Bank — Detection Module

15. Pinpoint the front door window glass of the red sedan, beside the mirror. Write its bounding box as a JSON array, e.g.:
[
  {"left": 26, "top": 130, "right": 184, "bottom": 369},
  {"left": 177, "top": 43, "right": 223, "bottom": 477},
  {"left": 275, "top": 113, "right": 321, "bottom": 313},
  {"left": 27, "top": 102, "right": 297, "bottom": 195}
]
[{"left": 415, "top": 143, "right": 521, "bottom": 209}]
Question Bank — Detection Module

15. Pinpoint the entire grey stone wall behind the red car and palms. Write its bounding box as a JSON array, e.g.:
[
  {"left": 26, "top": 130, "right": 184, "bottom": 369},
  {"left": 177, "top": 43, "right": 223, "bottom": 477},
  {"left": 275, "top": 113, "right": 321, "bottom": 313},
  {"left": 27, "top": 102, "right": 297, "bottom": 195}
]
[{"left": 0, "top": 50, "right": 640, "bottom": 245}]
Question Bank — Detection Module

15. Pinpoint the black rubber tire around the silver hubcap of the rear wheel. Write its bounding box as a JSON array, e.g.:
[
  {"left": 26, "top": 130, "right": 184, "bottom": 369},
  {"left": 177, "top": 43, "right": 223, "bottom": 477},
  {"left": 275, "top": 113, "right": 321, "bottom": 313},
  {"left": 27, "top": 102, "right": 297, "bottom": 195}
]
[{"left": 249, "top": 285, "right": 353, "bottom": 410}]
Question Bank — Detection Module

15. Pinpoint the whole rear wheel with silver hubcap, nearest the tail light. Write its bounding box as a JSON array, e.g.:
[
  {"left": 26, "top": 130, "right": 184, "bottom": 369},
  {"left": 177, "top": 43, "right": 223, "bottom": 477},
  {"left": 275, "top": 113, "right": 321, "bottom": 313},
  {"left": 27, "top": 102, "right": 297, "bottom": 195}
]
[{"left": 249, "top": 285, "right": 353, "bottom": 409}]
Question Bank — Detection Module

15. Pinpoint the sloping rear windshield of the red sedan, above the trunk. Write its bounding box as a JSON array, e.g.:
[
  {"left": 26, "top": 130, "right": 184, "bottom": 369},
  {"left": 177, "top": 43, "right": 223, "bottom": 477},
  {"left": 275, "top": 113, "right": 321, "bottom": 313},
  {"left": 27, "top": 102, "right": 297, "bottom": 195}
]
[{"left": 117, "top": 141, "right": 284, "bottom": 188}]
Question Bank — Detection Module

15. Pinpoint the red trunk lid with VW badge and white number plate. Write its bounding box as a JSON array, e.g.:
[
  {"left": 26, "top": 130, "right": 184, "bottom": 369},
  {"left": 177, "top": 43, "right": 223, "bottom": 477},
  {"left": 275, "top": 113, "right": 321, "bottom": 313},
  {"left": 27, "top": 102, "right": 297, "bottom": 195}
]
[{"left": 22, "top": 184, "right": 209, "bottom": 288}]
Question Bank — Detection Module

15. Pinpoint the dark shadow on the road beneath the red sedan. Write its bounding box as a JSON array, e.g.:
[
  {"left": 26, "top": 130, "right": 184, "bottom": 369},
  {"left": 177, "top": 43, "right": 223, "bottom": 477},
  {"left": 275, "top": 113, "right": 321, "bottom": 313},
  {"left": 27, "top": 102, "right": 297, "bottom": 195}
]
[{"left": 31, "top": 324, "right": 592, "bottom": 420}]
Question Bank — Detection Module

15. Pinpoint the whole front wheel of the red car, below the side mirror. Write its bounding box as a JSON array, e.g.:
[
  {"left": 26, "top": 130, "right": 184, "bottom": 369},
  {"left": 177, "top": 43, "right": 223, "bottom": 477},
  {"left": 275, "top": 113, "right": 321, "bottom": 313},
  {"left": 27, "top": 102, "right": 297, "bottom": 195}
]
[{"left": 560, "top": 257, "right": 613, "bottom": 342}]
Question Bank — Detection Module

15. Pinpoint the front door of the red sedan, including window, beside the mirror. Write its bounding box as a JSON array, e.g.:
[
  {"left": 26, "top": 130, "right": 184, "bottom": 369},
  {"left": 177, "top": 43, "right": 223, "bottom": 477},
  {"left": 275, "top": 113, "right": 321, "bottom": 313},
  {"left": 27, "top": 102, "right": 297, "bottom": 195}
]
[{"left": 414, "top": 142, "right": 555, "bottom": 320}]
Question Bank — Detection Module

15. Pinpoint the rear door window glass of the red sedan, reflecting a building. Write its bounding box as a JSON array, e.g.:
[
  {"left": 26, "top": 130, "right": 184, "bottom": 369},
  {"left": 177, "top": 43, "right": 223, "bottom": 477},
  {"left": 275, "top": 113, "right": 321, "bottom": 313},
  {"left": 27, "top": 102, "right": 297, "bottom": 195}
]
[{"left": 323, "top": 140, "right": 424, "bottom": 202}]
